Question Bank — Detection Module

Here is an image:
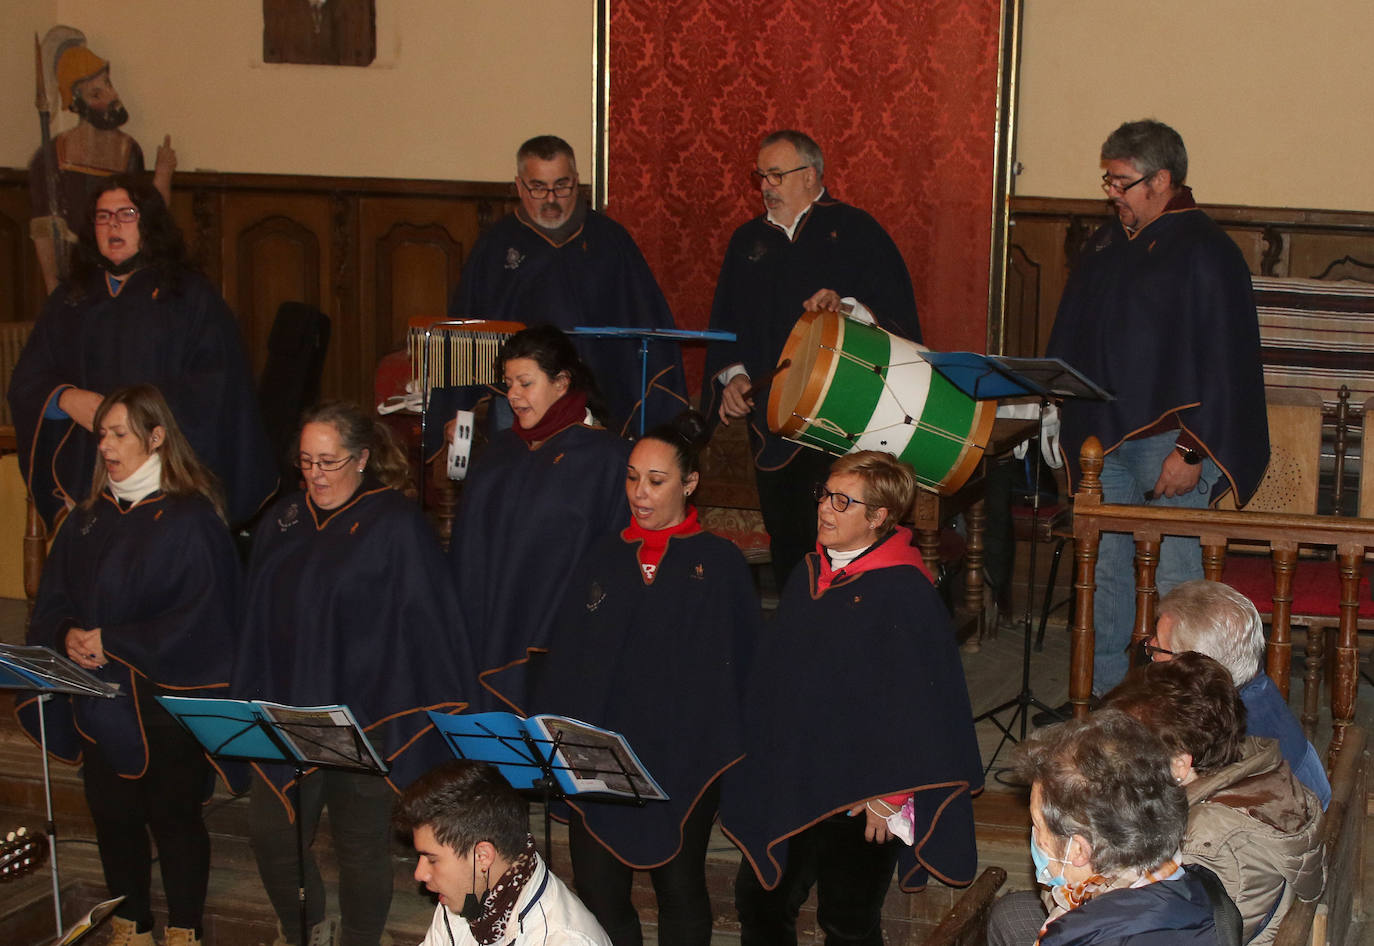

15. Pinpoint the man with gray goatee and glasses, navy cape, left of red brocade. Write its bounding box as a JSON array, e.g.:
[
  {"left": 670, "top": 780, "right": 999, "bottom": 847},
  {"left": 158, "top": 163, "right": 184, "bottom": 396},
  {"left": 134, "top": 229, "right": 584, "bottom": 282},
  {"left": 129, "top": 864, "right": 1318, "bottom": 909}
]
[{"left": 448, "top": 135, "right": 687, "bottom": 434}]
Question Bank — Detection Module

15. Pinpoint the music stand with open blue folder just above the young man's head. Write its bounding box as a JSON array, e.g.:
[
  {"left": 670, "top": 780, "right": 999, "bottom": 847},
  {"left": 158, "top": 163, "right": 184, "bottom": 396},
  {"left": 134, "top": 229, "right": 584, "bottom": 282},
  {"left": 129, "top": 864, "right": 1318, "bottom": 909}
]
[{"left": 430, "top": 710, "right": 668, "bottom": 868}]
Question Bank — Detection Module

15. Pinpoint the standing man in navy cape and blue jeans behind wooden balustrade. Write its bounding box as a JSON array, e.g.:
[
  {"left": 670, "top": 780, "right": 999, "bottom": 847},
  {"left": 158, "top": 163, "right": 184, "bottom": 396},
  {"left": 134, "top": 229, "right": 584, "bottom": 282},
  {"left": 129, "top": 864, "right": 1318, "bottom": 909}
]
[{"left": 1036, "top": 119, "right": 1270, "bottom": 725}]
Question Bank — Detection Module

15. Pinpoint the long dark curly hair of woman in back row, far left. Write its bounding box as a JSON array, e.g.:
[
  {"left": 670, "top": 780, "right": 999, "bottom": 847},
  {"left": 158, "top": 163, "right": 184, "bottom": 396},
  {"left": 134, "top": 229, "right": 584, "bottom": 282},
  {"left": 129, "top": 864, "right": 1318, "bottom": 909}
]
[{"left": 67, "top": 174, "right": 191, "bottom": 302}]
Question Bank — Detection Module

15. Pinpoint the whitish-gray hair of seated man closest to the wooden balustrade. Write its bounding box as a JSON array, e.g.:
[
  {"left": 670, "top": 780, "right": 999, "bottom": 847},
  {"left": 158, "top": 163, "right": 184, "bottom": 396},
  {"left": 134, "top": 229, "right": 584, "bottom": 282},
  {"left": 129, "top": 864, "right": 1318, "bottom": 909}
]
[{"left": 1158, "top": 578, "right": 1264, "bottom": 687}]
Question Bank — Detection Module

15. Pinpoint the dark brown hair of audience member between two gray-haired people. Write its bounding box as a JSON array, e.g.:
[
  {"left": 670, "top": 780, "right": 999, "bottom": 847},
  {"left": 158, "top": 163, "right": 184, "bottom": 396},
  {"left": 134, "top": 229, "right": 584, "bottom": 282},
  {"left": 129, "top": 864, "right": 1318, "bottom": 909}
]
[{"left": 1103, "top": 651, "right": 1245, "bottom": 773}]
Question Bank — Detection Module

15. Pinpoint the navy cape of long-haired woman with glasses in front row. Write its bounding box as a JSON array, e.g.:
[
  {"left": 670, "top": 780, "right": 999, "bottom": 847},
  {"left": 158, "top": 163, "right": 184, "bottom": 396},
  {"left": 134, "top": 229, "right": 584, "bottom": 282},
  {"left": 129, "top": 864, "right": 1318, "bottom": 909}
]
[{"left": 234, "top": 478, "right": 475, "bottom": 810}]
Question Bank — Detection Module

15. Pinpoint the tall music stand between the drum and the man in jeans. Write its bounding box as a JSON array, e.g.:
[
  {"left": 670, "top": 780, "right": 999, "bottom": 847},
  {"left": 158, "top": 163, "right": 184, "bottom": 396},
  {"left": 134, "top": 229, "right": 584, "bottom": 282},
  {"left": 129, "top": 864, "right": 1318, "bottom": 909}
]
[{"left": 921, "top": 351, "right": 1113, "bottom": 776}]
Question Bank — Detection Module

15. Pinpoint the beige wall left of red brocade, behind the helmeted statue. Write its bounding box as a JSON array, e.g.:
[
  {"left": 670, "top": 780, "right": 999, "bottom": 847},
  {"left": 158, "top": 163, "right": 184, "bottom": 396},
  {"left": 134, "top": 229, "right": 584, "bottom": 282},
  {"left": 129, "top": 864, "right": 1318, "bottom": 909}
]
[{"left": 0, "top": 0, "right": 595, "bottom": 180}]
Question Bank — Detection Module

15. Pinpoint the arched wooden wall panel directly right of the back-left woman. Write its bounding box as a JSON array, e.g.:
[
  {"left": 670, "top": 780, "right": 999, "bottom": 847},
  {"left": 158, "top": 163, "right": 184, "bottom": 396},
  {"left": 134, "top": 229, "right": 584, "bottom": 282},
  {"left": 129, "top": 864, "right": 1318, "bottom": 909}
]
[{"left": 220, "top": 192, "right": 336, "bottom": 397}]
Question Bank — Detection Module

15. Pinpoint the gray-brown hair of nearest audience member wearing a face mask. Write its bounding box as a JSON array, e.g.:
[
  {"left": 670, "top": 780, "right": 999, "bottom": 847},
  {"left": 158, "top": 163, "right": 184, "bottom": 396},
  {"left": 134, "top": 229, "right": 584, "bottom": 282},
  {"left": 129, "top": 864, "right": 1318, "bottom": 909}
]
[{"left": 1014, "top": 708, "right": 1189, "bottom": 877}]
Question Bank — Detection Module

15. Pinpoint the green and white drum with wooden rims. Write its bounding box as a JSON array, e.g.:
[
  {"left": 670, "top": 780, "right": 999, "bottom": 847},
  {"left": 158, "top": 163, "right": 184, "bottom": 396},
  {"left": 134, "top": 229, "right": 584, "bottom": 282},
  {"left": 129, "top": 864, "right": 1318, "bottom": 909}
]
[{"left": 768, "top": 312, "right": 998, "bottom": 493}]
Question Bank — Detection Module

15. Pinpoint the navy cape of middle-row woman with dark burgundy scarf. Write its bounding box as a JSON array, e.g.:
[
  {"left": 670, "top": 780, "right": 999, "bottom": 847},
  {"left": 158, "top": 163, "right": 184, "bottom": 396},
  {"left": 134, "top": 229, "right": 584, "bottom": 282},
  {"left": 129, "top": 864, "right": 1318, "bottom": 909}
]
[{"left": 449, "top": 423, "right": 629, "bottom": 711}]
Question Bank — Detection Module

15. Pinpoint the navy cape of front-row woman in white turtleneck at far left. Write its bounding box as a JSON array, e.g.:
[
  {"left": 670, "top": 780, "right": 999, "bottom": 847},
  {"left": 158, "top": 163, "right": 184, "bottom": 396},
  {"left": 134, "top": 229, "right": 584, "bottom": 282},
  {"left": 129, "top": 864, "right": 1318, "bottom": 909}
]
[{"left": 18, "top": 492, "right": 239, "bottom": 779}]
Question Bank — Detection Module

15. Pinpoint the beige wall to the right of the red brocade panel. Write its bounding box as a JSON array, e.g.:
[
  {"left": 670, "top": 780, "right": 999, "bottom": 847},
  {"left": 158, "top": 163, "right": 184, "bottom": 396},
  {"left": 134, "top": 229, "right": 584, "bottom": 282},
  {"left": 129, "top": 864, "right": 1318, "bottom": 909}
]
[{"left": 1017, "top": 0, "right": 1374, "bottom": 210}]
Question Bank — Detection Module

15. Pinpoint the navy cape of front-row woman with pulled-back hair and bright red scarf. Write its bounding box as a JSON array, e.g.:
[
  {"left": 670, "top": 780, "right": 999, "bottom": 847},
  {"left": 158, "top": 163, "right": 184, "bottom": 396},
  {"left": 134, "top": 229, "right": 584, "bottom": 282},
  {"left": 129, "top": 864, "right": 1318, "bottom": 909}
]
[{"left": 532, "top": 531, "right": 760, "bottom": 870}]
